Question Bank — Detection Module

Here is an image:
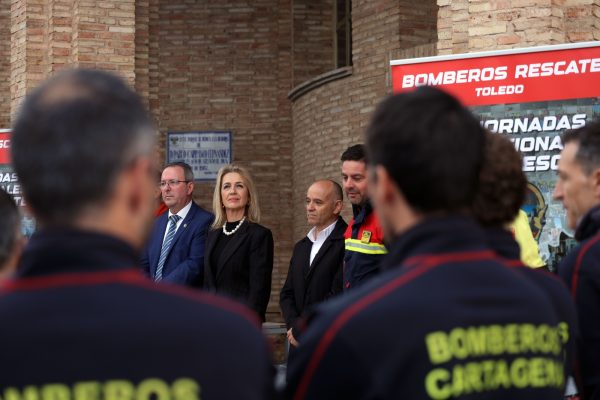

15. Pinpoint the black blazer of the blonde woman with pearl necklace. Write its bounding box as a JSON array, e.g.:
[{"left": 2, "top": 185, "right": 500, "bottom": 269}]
[{"left": 204, "top": 222, "right": 273, "bottom": 321}]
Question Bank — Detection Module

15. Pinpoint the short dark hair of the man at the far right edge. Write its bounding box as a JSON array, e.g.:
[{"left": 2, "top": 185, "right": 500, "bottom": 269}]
[{"left": 562, "top": 120, "right": 600, "bottom": 174}]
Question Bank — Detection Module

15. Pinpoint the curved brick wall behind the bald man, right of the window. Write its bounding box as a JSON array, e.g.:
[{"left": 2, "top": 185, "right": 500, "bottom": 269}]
[{"left": 293, "top": 0, "right": 436, "bottom": 241}]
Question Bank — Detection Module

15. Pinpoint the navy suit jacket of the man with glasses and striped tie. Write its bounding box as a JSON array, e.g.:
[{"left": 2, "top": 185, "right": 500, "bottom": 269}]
[{"left": 141, "top": 201, "right": 214, "bottom": 287}]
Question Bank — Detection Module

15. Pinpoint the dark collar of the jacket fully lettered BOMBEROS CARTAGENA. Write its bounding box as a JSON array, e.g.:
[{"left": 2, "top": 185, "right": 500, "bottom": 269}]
[{"left": 382, "top": 215, "right": 489, "bottom": 269}]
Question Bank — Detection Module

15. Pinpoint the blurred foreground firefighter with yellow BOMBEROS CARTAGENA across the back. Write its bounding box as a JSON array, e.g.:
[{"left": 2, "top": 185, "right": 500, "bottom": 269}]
[{"left": 287, "top": 87, "right": 576, "bottom": 400}]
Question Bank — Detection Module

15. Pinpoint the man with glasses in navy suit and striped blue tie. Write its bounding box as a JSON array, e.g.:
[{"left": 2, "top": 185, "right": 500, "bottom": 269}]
[{"left": 141, "top": 162, "right": 214, "bottom": 287}]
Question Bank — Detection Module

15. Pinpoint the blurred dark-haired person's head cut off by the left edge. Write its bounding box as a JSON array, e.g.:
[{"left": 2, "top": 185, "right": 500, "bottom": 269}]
[{"left": 0, "top": 189, "right": 25, "bottom": 281}]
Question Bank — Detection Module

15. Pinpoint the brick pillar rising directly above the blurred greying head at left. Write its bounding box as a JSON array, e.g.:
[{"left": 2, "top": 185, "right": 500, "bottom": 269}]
[{"left": 9, "top": 0, "right": 136, "bottom": 118}]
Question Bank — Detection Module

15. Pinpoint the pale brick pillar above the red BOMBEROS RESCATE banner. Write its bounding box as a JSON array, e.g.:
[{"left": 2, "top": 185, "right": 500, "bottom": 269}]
[{"left": 437, "top": 0, "right": 600, "bottom": 54}]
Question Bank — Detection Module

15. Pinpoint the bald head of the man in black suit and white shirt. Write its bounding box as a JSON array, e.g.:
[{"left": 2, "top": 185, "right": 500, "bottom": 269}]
[{"left": 306, "top": 179, "right": 343, "bottom": 231}]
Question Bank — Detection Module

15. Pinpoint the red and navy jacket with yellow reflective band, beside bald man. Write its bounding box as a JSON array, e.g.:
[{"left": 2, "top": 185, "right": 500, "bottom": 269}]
[{"left": 344, "top": 203, "right": 387, "bottom": 290}]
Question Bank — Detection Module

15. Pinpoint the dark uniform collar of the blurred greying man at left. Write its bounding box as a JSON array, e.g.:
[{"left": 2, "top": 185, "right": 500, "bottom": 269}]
[{"left": 17, "top": 227, "right": 138, "bottom": 277}]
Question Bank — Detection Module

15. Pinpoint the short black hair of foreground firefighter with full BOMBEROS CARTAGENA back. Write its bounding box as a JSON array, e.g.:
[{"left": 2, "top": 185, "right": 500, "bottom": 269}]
[{"left": 367, "top": 86, "right": 484, "bottom": 213}]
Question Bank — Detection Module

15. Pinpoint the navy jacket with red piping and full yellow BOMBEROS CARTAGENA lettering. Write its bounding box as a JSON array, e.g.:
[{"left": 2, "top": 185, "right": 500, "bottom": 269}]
[{"left": 287, "top": 217, "right": 568, "bottom": 400}]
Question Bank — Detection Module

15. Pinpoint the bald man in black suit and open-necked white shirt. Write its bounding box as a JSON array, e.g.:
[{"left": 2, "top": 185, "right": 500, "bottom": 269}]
[{"left": 279, "top": 180, "right": 347, "bottom": 347}]
